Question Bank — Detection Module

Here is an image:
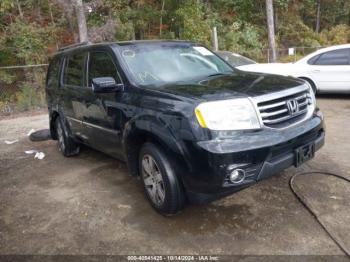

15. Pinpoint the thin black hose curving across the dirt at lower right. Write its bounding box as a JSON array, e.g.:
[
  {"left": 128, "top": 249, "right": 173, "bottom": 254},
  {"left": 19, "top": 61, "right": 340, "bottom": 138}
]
[{"left": 289, "top": 171, "right": 350, "bottom": 257}]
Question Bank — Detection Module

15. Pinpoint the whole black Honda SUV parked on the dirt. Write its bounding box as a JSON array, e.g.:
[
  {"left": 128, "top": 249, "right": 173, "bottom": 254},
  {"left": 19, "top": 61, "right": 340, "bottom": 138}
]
[{"left": 46, "top": 41, "right": 325, "bottom": 215}]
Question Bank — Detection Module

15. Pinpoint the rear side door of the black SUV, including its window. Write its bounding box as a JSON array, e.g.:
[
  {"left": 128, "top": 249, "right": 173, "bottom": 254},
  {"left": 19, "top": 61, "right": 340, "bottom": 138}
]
[{"left": 62, "top": 52, "right": 88, "bottom": 142}]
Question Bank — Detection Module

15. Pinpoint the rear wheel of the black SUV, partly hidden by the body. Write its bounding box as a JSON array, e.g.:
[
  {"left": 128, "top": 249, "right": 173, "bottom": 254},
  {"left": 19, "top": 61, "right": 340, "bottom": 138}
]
[{"left": 55, "top": 117, "right": 80, "bottom": 157}]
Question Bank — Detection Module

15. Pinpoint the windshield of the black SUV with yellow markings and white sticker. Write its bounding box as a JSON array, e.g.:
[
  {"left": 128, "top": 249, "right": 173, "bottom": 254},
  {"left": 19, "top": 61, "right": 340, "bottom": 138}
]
[{"left": 120, "top": 42, "right": 234, "bottom": 86}]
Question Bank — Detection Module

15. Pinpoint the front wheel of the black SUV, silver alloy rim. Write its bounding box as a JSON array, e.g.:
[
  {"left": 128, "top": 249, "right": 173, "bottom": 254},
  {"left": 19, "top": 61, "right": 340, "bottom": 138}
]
[{"left": 139, "top": 143, "right": 185, "bottom": 216}]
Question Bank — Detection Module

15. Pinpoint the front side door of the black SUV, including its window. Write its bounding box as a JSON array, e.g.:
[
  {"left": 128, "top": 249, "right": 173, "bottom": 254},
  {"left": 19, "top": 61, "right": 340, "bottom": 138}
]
[{"left": 83, "top": 50, "right": 123, "bottom": 157}]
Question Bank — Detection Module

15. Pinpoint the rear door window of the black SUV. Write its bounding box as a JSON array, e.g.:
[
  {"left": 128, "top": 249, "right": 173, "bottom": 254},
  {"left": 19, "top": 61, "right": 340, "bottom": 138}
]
[{"left": 64, "top": 53, "right": 85, "bottom": 86}]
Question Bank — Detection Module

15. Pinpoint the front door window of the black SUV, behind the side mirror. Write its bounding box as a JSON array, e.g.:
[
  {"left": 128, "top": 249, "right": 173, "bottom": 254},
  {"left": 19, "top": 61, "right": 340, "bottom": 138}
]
[{"left": 89, "top": 52, "right": 121, "bottom": 86}]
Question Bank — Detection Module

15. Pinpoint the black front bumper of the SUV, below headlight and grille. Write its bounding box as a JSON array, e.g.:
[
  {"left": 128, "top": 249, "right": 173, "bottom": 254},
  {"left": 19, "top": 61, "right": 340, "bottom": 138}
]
[{"left": 183, "top": 111, "right": 325, "bottom": 202}]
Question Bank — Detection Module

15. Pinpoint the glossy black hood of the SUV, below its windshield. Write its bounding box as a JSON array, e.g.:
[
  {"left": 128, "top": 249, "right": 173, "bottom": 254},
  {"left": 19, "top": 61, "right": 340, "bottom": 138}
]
[{"left": 155, "top": 71, "right": 303, "bottom": 101}]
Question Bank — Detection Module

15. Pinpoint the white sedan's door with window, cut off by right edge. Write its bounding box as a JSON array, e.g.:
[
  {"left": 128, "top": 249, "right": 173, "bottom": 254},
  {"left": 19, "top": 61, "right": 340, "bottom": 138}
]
[{"left": 310, "top": 48, "right": 350, "bottom": 92}]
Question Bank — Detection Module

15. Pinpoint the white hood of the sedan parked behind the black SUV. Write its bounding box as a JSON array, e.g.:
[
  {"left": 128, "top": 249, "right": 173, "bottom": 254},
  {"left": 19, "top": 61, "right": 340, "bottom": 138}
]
[{"left": 237, "top": 63, "right": 293, "bottom": 76}]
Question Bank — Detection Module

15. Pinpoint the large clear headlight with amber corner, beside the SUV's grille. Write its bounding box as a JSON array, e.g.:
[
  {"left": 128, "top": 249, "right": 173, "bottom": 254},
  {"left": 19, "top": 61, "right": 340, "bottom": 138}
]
[{"left": 195, "top": 98, "right": 260, "bottom": 131}]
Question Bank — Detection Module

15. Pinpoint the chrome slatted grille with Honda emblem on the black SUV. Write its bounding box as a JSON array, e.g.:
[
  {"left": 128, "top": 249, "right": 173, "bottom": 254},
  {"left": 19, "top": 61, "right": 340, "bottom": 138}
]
[{"left": 257, "top": 90, "right": 312, "bottom": 128}]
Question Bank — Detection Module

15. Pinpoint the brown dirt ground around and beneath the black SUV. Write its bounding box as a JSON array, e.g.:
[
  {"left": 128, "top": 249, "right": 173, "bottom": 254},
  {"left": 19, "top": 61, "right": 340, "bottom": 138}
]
[{"left": 0, "top": 96, "right": 350, "bottom": 255}]
